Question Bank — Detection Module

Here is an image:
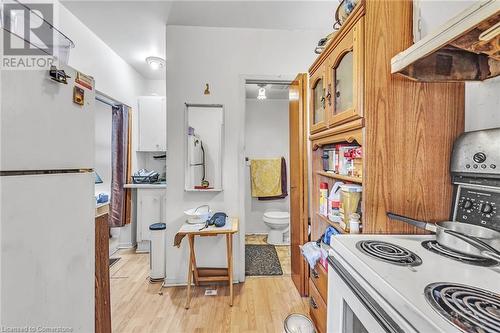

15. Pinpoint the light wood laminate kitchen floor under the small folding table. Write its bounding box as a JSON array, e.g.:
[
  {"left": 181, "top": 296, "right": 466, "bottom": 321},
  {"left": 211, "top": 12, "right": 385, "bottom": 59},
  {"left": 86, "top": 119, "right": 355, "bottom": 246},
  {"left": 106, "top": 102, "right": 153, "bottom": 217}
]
[{"left": 110, "top": 250, "right": 308, "bottom": 333}]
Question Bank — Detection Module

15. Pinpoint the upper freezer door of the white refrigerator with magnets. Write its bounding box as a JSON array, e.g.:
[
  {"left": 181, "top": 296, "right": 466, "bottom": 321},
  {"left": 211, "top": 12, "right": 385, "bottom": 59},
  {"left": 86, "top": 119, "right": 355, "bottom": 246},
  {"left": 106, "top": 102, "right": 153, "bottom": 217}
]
[{"left": 0, "top": 67, "right": 95, "bottom": 171}]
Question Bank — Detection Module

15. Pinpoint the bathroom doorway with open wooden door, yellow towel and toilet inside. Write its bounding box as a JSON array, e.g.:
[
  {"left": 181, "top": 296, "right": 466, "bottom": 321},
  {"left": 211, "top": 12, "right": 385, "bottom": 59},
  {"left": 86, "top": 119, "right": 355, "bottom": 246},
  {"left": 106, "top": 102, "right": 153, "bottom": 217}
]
[{"left": 243, "top": 76, "right": 307, "bottom": 286}]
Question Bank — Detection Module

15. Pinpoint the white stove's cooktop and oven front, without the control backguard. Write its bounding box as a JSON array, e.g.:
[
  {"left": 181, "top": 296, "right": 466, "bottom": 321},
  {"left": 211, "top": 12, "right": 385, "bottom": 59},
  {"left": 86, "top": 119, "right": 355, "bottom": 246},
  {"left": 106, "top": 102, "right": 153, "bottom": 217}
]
[{"left": 327, "top": 235, "right": 500, "bottom": 333}]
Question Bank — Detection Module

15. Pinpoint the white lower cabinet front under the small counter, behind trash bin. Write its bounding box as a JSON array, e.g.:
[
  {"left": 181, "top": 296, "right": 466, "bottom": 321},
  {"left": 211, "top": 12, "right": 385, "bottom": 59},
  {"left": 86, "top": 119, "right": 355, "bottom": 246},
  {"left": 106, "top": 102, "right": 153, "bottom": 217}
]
[{"left": 137, "top": 189, "right": 164, "bottom": 241}]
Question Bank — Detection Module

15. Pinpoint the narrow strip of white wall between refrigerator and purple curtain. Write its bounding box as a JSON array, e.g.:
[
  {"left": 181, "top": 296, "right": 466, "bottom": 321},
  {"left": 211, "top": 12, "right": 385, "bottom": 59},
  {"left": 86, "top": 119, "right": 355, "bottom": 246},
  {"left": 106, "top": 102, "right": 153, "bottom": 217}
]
[{"left": 94, "top": 101, "right": 112, "bottom": 195}]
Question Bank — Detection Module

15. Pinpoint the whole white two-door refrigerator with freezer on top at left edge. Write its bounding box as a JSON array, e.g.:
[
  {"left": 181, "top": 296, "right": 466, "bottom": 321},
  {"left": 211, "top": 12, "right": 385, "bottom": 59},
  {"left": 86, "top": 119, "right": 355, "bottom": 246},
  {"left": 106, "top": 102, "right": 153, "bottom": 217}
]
[{"left": 0, "top": 67, "right": 95, "bottom": 332}]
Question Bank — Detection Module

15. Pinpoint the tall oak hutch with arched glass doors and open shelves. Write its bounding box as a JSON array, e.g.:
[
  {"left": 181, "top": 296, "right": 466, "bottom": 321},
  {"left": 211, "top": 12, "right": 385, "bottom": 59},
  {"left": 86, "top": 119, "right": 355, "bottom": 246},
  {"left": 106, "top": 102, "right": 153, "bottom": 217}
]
[{"left": 309, "top": 0, "right": 464, "bottom": 239}]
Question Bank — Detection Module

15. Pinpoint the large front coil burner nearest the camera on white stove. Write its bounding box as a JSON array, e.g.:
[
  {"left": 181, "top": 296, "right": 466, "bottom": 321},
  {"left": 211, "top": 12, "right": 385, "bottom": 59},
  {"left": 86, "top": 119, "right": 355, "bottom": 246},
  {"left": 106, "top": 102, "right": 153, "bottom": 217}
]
[{"left": 425, "top": 282, "right": 500, "bottom": 333}]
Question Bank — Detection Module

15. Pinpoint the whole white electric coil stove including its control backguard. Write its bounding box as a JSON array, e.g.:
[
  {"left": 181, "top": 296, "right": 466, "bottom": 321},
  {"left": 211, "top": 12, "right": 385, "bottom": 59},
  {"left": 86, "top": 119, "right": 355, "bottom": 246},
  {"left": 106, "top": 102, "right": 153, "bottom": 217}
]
[{"left": 327, "top": 128, "right": 500, "bottom": 333}]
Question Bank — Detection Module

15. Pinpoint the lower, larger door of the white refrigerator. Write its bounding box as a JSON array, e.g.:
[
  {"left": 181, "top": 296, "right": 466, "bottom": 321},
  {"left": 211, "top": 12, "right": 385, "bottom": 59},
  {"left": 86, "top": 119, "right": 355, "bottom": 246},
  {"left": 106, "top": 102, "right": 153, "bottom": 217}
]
[{"left": 0, "top": 173, "right": 95, "bottom": 333}]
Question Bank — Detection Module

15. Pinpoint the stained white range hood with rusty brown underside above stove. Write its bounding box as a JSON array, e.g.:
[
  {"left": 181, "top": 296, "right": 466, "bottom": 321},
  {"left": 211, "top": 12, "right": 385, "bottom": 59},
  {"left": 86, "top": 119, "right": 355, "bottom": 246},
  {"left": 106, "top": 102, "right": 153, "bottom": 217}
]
[{"left": 391, "top": 0, "right": 500, "bottom": 82}]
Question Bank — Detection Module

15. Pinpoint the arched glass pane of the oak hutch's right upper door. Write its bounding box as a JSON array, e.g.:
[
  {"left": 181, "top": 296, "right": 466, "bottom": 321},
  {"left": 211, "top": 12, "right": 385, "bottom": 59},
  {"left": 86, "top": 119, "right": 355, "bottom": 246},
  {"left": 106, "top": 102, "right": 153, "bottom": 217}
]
[{"left": 332, "top": 50, "right": 354, "bottom": 115}]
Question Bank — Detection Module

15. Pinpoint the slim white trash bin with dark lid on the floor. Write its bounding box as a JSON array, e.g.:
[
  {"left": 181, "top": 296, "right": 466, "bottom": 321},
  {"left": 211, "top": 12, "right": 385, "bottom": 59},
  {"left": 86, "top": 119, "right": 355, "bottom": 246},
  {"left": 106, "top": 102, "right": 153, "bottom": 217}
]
[{"left": 149, "top": 223, "right": 167, "bottom": 282}]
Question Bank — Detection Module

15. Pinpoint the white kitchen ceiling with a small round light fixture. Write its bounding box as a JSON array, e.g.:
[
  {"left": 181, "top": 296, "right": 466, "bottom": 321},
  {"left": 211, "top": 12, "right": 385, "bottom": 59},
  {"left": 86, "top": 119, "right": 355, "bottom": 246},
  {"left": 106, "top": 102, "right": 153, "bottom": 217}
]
[{"left": 62, "top": 0, "right": 338, "bottom": 79}]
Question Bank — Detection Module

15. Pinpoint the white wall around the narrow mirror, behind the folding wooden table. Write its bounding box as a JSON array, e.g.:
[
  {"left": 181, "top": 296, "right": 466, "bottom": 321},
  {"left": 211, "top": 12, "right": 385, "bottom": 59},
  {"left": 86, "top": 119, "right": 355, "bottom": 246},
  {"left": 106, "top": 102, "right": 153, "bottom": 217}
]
[{"left": 166, "top": 26, "right": 324, "bottom": 283}]
